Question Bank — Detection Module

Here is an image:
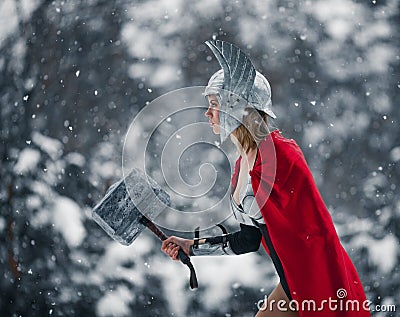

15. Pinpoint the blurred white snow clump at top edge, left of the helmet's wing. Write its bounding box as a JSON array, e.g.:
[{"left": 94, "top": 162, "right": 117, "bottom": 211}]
[{"left": 121, "top": 0, "right": 190, "bottom": 87}]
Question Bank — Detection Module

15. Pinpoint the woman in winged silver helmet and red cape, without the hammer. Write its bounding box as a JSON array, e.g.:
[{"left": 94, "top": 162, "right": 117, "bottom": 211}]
[{"left": 162, "top": 41, "right": 370, "bottom": 317}]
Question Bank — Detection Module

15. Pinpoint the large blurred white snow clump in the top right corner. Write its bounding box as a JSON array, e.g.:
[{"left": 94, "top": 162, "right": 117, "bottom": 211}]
[{"left": 307, "top": 0, "right": 396, "bottom": 80}]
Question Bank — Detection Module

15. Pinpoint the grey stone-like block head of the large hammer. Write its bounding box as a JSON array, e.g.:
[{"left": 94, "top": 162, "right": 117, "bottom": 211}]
[{"left": 92, "top": 168, "right": 170, "bottom": 245}]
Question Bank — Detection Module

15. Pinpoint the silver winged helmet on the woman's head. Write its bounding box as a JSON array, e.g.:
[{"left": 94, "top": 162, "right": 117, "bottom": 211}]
[{"left": 204, "top": 41, "right": 276, "bottom": 142}]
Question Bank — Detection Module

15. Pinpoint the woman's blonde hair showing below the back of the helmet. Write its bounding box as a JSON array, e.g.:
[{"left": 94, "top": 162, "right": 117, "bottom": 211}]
[{"left": 233, "top": 108, "right": 269, "bottom": 153}]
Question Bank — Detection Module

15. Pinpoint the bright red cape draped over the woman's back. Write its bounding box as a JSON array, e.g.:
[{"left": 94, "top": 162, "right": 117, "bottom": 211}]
[{"left": 232, "top": 131, "right": 370, "bottom": 317}]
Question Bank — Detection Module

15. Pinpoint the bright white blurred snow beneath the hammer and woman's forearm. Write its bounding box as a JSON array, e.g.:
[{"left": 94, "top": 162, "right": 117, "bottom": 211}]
[{"left": 87, "top": 228, "right": 277, "bottom": 316}]
